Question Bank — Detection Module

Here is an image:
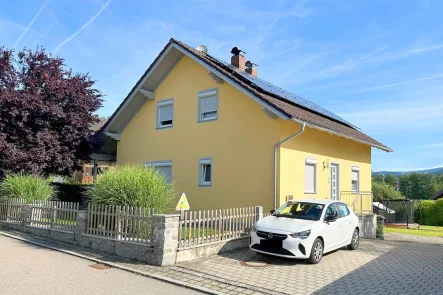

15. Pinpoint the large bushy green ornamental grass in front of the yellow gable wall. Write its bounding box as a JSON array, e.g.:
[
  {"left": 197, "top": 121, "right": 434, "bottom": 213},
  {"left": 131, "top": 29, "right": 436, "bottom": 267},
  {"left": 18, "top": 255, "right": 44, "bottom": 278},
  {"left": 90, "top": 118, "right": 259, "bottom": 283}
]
[{"left": 87, "top": 165, "right": 175, "bottom": 213}]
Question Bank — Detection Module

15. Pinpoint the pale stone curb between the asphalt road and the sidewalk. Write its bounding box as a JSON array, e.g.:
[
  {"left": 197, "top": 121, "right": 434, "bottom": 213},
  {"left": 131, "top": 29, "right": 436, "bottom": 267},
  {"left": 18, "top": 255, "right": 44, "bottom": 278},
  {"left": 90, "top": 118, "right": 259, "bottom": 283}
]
[{"left": 0, "top": 231, "right": 225, "bottom": 295}]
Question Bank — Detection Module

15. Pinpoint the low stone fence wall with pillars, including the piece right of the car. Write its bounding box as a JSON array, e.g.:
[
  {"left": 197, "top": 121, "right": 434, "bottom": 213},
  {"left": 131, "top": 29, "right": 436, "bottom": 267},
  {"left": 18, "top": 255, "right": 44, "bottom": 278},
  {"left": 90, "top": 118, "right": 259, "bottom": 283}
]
[{"left": 0, "top": 205, "right": 377, "bottom": 266}]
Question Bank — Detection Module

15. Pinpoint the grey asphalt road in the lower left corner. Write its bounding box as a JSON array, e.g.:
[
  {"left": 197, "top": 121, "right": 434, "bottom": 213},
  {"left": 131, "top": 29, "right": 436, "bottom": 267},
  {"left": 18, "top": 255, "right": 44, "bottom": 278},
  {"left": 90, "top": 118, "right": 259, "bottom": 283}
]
[{"left": 0, "top": 235, "right": 202, "bottom": 295}]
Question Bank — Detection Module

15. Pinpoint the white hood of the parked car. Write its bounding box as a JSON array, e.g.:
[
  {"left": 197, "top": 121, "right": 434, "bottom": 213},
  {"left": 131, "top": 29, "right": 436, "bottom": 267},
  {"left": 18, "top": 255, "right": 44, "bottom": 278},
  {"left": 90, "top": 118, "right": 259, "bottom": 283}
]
[{"left": 255, "top": 216, "right": 318, "bottom": 233}]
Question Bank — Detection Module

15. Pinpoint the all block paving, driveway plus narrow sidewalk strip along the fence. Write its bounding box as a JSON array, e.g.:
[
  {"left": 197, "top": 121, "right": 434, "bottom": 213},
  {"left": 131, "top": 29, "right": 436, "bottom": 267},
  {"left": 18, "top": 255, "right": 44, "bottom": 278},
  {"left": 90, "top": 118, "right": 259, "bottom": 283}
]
[{"left": 3, "top": 232, "right": 443, "bottom": 295}]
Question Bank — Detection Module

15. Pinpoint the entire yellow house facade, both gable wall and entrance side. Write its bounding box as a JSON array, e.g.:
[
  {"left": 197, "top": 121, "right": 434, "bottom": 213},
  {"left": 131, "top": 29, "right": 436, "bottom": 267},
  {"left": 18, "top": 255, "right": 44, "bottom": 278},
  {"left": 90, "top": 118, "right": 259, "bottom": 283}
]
[{"left": 117, "top": 56, "right": 371, "bottom": 210}]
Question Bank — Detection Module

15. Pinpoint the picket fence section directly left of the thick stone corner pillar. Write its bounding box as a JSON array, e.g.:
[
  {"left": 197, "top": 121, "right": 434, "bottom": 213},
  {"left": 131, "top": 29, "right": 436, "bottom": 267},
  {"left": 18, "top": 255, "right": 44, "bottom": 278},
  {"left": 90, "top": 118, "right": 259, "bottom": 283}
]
[{"left": 87, "top": 204, "right": 154, "bottom": 243}]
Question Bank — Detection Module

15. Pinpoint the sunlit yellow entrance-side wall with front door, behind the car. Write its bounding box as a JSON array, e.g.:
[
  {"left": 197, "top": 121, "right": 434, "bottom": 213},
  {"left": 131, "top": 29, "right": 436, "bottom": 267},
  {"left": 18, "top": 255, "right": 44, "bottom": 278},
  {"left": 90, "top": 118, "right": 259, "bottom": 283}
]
[{"left": 278, "top": 121, "right": 372, "bottom": 211}]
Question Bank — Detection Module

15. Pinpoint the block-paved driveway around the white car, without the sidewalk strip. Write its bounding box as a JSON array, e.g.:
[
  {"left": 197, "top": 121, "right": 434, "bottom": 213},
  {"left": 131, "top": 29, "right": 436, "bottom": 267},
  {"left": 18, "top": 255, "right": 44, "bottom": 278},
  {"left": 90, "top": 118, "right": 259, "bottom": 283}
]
[{"left": 179, "top": 238, "right": 443, "bottom": 294}]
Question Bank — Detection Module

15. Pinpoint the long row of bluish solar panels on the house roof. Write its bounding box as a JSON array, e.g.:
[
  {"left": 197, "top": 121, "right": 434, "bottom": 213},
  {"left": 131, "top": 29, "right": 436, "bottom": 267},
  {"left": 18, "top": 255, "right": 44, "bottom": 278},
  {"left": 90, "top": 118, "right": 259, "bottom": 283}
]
[{"left": 212, "top": 56, "right": 357, "bottom": 128}]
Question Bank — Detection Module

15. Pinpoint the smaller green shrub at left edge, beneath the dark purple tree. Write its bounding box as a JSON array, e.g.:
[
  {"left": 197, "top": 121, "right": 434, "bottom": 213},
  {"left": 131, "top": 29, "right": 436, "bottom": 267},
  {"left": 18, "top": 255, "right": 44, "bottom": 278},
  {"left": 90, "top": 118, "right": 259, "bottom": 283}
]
[{"left": 0, "top": 174, "right": 56, "bottom": 202}]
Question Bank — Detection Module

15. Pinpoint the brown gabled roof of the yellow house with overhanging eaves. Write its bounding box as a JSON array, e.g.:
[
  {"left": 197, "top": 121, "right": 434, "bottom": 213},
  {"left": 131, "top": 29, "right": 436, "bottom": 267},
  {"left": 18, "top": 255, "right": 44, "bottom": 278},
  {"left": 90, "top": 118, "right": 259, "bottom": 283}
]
[{"left": 104, "top": 38, "right": 392, "bottom": 152}]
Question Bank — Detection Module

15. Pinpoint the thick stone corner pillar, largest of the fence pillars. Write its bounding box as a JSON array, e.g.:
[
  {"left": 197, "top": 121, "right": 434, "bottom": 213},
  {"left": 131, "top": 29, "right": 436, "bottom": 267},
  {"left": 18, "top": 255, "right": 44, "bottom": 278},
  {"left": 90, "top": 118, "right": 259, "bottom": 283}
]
[{"left": 151, "top": 214, "right": 180, "bottom": 266}]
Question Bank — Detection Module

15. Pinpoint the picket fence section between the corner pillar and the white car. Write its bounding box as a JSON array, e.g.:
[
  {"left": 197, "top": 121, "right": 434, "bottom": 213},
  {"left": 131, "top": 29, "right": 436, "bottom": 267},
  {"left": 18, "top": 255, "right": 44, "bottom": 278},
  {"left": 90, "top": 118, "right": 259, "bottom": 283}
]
[{"left": 178, "top": 207, "right": 257, "bottom": 248}]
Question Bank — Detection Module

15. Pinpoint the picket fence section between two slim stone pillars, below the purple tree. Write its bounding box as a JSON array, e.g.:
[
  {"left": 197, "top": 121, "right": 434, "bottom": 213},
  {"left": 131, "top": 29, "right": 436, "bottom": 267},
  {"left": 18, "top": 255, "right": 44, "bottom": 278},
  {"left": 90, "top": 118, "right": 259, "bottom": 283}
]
[{"left": 30, "top": 201, "right": 79, "bottom": 232}]
